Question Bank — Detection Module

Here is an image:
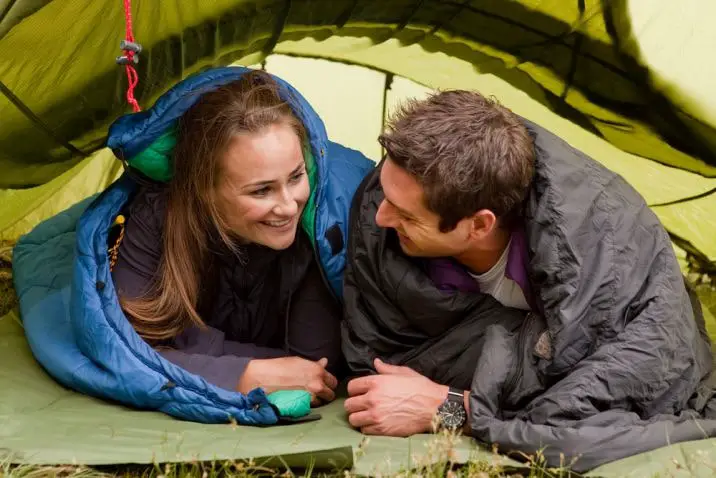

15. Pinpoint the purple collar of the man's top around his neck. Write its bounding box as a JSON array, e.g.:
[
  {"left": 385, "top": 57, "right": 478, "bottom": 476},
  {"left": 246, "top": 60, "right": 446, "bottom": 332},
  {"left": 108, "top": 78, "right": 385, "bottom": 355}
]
[{"left": 426, "top": 227, "right": 534, "bottom": 309}]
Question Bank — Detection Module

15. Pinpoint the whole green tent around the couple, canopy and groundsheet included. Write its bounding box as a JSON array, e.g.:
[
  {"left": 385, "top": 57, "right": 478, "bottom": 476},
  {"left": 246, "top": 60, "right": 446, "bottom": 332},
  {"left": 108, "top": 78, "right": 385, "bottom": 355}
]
[{"left": 0, "top": 0, "right": 716, "bottom": 476}]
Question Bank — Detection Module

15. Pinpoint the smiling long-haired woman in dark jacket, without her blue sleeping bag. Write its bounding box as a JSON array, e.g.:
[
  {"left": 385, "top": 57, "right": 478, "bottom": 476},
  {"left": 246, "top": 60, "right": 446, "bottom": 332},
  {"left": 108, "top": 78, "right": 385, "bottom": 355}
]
[{"left": 112, "top": 71, "right": 368, "bottom": 404}]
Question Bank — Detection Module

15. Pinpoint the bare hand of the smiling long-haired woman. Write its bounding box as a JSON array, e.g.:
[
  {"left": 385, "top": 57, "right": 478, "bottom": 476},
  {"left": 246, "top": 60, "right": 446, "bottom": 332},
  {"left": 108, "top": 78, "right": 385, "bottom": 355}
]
[{"left": 236, "top": 357, "right": 338, "bottom": 405}]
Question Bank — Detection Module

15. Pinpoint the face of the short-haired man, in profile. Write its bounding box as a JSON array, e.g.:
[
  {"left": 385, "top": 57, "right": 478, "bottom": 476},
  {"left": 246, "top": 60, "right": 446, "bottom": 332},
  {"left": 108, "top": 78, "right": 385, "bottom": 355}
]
[{"left": 375, "top": 158, "right": 472, "bottom": 257}]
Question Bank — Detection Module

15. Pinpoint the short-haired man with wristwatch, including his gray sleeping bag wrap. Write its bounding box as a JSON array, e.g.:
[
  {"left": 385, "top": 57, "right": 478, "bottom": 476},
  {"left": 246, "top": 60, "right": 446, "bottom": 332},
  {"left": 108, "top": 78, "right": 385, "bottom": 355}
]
[{"left": 343, "top": 91, "right": 716, "bottom": 471}]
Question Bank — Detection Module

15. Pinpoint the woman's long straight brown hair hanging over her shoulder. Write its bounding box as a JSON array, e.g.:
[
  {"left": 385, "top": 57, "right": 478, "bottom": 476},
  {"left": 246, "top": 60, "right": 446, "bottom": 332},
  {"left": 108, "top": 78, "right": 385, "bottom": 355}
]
[{"left": 120, "top": 70, "right": 306, "bottom": 342}]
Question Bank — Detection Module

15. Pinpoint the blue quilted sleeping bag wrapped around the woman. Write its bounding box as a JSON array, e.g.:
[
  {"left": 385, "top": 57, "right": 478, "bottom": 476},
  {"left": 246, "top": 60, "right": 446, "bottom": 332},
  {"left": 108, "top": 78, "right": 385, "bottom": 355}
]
[{"left": 13, "top": 67, "right": 374, "bottom": 425}]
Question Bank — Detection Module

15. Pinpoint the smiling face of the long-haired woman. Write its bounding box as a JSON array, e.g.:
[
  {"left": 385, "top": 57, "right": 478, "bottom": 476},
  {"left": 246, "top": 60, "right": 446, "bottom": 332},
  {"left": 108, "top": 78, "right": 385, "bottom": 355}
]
[{"left": 218, "top": 123, "right": 310, "bottom": 250}]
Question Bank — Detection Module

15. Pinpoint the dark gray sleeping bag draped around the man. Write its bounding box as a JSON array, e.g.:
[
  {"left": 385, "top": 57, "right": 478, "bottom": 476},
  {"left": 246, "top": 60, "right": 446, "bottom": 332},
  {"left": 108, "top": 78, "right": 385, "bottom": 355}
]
[{"left": 343, "top": 118, "right": 716, "bottom": 471}]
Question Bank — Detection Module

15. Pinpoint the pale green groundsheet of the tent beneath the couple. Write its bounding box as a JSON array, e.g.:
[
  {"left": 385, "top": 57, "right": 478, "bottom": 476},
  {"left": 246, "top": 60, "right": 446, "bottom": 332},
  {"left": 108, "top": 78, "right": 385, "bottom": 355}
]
[{"left": 0, "top": 311, "right": 716, "bottom": 476}]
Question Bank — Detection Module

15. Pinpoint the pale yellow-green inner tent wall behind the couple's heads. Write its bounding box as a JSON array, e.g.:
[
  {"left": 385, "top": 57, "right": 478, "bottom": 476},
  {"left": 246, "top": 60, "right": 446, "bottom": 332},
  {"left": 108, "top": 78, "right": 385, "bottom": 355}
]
[{"left": 5, "top": 51, "right": 716, "bottom": 267}]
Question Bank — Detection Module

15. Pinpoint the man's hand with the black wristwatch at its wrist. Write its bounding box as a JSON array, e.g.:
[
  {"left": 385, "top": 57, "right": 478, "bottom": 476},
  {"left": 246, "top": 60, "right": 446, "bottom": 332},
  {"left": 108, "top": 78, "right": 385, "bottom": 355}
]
[{"left": 345, "top": 359, "right": 448, "bottom": 437}]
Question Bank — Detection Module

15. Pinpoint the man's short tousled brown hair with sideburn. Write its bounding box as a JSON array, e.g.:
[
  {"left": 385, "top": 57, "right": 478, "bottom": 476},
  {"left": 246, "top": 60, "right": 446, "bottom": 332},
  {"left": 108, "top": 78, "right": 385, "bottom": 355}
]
[{"left": 378, "top": 90, "right": 534, "bottom": 232}]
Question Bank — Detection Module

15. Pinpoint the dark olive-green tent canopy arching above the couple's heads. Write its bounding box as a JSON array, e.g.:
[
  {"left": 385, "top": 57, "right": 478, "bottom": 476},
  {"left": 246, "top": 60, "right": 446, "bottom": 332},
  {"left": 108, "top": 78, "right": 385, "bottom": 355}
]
[{"left": 0, "top": 0, "right": 716, "bottom": 187}]
